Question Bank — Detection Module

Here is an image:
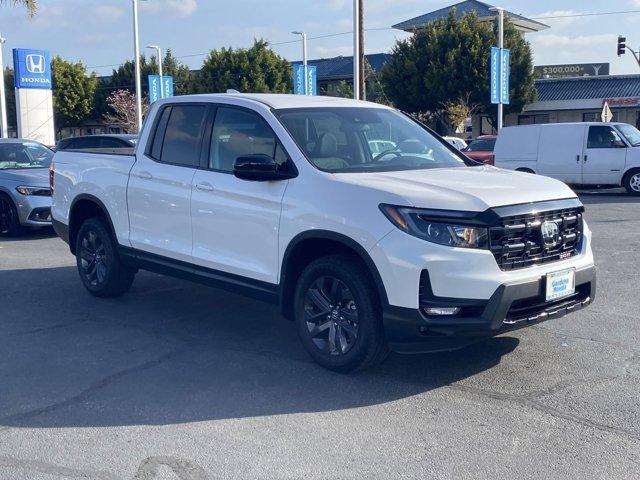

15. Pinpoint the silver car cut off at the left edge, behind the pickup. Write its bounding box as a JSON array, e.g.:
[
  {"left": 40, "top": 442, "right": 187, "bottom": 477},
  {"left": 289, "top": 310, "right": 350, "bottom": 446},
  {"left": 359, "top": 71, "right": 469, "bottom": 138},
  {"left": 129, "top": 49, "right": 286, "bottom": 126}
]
[{"left": 0, "top": 139, "right": 53, "bottom": 236}]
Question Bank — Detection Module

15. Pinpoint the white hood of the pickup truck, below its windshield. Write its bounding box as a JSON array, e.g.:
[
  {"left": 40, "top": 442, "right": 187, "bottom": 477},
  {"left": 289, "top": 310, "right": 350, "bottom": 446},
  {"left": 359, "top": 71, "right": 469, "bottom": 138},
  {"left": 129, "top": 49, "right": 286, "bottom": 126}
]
[{"left": 336, "top": 166, "right": 576, "bottom": 212}]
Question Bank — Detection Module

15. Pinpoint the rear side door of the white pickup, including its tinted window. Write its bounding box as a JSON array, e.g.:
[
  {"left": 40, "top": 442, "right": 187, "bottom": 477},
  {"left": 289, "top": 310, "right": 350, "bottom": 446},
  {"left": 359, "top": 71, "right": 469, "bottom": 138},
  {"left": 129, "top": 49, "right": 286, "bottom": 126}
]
[{"left": 129, "top": 103, "right": 209, "bottom": 261}]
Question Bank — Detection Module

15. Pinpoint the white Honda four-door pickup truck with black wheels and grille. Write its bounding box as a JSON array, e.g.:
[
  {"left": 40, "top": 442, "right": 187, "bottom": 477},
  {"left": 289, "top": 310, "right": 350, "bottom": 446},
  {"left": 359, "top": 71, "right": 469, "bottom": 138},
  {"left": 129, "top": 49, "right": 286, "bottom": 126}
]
[{"left": 50, "top": 94, "right": 596, "bottom": 372}]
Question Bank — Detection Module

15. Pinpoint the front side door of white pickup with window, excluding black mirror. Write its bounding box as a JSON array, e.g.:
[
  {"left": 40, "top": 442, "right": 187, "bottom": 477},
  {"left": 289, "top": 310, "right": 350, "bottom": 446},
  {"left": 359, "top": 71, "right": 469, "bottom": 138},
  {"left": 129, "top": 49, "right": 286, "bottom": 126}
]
[{"left": 191, "top": 106, "right": 288, "bottom": 284}]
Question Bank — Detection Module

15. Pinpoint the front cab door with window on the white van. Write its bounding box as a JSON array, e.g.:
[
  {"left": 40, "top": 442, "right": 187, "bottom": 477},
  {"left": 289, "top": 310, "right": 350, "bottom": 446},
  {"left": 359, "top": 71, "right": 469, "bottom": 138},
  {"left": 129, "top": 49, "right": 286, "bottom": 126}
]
[{"left": 582, "top": 125, "right": 628, "bottom": 185}]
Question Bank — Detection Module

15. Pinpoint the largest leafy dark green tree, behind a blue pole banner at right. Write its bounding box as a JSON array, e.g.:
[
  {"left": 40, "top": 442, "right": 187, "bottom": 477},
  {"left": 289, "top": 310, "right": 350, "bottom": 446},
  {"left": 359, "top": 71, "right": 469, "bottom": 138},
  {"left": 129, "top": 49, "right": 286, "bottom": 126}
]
[{"left": 382, "top": 10, "right": 536, "bottom": 131}]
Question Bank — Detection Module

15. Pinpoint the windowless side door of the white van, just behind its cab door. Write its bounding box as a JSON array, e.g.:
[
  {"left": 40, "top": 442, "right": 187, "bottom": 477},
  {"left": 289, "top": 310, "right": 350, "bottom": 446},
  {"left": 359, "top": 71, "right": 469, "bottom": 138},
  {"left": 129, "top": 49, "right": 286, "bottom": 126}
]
[{"left": 537, "top": 123, "right": 586, "bottom": 184}]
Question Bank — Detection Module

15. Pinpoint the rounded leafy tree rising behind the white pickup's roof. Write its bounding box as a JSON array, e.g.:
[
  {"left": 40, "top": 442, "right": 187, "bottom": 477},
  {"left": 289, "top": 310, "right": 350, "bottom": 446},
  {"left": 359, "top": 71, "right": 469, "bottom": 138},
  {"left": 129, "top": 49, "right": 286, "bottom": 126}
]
[{"left": 198, "top": 40, "right": 293, "bottom": 93}]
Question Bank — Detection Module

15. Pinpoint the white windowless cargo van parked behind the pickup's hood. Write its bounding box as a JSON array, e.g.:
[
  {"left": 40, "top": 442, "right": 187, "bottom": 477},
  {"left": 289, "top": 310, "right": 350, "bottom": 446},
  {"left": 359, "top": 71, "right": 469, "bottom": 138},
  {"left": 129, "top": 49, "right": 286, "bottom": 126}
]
[{"left": 494, "top": 122, "right": 640, "bottom": 195}]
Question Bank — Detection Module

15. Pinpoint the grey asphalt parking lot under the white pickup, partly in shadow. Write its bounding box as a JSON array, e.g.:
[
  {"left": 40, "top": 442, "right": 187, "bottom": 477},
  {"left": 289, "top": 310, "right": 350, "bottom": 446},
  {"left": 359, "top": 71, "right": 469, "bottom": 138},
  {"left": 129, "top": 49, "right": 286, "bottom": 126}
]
[{"left": 0, "top": 191, "right": 640, "bottom": 480}]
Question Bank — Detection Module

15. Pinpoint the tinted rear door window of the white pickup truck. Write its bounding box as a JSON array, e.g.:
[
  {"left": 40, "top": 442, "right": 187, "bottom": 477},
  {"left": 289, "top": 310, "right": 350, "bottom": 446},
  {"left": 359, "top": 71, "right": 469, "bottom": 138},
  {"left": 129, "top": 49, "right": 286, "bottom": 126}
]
[{"left": 159, "top": 105, "right": 207, "bottom": 167}]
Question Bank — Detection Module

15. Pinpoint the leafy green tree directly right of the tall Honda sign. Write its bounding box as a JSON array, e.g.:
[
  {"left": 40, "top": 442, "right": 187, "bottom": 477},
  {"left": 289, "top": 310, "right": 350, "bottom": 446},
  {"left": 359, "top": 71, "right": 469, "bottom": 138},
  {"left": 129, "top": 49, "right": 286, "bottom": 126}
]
[{"left": 51, "top": 57, "right": 98, "bottom": 127}]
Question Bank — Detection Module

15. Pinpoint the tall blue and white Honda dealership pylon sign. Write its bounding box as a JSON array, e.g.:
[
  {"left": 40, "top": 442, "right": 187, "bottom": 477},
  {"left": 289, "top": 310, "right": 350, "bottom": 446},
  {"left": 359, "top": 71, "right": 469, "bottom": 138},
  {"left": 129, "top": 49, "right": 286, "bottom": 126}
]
[{"left": 13, "top": 48, "right": 56, "bottom": 145}]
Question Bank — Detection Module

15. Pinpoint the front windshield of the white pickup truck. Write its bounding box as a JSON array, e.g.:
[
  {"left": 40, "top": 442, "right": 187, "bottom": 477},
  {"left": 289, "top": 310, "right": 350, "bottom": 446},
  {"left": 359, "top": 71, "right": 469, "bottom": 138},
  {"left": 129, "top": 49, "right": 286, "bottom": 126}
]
[{"left": 276, "top": 107, "right": 466, "bottom": 173}]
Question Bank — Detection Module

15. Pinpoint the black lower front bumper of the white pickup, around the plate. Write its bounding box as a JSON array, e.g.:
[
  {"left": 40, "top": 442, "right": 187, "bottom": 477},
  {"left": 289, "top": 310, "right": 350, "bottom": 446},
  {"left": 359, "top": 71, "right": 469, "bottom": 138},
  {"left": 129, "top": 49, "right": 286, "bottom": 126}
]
[{"left": 383, "top": 266, "right": 596, "bottom": 353}]
